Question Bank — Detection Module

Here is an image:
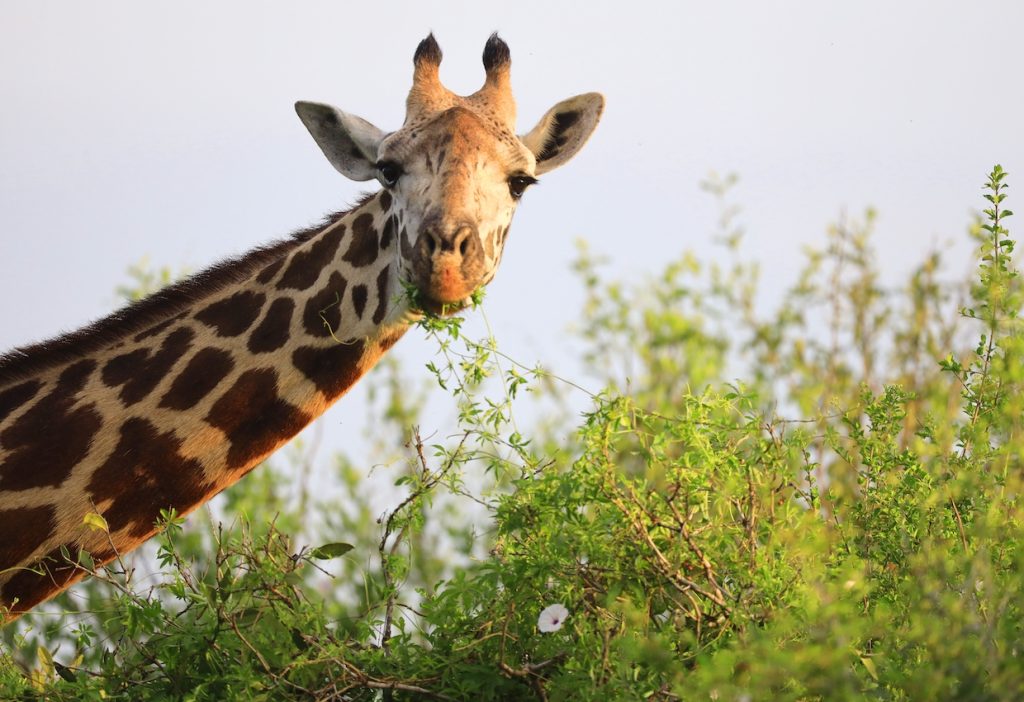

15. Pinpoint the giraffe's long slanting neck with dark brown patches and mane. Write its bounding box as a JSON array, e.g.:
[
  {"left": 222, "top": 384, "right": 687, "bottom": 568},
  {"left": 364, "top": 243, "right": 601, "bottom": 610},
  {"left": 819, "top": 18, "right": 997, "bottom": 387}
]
[{"left": 0, "top": 191, "right": 411, "bottom": 613}]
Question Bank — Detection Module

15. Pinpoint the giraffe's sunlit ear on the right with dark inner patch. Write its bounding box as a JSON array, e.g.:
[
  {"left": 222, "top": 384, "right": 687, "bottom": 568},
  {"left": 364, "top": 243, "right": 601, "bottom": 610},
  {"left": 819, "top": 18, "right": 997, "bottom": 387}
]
[{"left": 519, "top": 93, "right": 604, "bottom": 175}]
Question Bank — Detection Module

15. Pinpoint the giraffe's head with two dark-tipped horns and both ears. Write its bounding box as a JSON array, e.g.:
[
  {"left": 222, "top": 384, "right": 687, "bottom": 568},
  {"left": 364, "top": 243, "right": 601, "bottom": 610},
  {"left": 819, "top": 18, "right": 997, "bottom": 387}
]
[{"left": 296, "top": 34, "right": 604, "bottom": 312}]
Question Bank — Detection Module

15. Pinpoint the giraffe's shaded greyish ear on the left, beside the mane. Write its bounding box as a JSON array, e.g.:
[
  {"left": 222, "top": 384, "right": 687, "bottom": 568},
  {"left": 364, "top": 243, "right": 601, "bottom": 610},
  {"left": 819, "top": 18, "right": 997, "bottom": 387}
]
[{"left": 295, "top": 102, "right": 385, "bottom": 180}]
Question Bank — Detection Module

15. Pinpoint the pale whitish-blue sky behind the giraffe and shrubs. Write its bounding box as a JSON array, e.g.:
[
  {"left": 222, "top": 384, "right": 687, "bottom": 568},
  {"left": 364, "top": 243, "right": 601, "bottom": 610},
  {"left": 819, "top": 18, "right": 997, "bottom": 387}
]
[{"left": 0, "top": 0, "right": 1024, "bottom": 462}]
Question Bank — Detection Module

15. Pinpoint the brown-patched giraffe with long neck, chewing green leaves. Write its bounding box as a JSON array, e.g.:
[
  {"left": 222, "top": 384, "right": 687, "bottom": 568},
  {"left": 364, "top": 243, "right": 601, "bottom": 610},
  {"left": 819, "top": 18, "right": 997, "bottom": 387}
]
[{"left": 0, "top": 34, "right": 604, "bottom": 621}]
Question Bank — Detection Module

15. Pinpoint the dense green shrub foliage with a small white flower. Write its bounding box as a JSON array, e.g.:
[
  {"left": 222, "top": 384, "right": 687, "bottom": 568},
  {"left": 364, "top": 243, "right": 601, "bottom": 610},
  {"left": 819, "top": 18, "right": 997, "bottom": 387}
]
[{"left": 0, "top": 167, "right": 1024, "bottom": 700}]
